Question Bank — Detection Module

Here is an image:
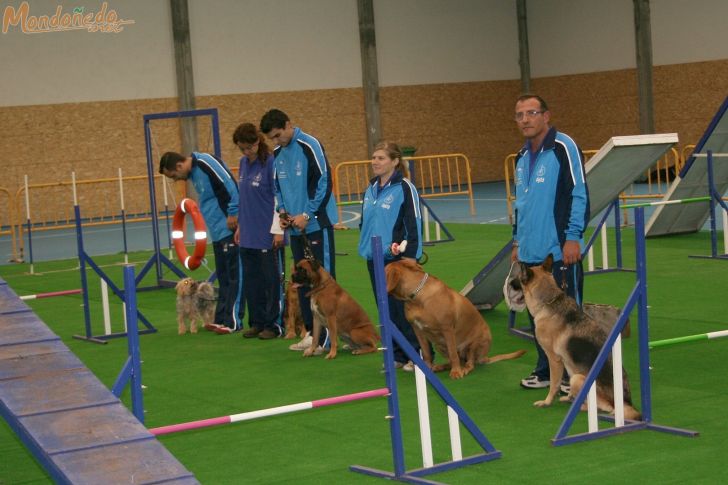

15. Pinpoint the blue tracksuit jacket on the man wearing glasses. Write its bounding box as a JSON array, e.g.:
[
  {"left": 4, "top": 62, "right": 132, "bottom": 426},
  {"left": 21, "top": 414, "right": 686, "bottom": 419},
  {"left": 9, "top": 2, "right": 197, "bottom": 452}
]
[{"left": 513, "top": 127, "right": 589, "bottom": 264}]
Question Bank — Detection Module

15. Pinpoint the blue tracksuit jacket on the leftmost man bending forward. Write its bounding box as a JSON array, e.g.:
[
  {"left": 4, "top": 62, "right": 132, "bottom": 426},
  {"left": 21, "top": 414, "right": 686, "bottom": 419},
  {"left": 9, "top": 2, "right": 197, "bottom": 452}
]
[{"left": 189, "top": 152, "right": 238, "bottom": 242}]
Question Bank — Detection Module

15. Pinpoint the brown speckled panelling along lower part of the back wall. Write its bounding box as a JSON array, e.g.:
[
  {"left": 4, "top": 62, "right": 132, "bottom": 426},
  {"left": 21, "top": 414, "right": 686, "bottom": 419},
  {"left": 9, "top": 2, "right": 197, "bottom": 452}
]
[{"left": 0, "top": 60, "right": 728, "bottom": 229}]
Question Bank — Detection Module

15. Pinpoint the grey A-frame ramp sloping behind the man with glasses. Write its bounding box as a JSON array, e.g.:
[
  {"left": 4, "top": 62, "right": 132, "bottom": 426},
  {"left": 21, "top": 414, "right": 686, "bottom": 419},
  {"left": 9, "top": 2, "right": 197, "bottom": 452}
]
[{"left": 460, "top": 133, "right": 680, "bottom": 310}]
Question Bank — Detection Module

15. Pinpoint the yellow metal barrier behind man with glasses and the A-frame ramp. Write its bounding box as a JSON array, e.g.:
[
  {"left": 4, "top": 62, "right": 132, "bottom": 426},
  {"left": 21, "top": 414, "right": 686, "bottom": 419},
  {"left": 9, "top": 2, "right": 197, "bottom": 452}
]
[{"left": 504, "top": 145, "right": 695, "bottom": 224}]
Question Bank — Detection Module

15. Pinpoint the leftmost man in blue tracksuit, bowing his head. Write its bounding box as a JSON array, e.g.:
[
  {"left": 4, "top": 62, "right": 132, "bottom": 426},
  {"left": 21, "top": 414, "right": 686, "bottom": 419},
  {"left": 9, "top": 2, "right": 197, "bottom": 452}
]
[{"left": 159, "top": 152, "right": 242, "bottom": 334}]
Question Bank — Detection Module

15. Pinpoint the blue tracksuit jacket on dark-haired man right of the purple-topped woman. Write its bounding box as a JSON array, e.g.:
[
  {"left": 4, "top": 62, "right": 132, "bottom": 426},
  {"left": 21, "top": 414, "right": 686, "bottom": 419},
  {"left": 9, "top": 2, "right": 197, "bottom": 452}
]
[{"left": 273, "top": 128, "right": 339, "bottom": 235}]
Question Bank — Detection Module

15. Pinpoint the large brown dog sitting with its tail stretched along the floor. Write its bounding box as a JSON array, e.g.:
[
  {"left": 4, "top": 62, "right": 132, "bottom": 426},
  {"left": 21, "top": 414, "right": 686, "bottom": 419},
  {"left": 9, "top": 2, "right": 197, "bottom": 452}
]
[{"left": 385, "top": 259, "right": 526, "bottom": 379}]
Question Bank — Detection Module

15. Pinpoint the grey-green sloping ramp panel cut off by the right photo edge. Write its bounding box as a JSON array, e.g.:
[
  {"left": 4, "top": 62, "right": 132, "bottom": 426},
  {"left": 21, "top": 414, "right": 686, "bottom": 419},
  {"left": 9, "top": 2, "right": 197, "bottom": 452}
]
[{"left": 645, "top": 97, "right": 728, "bottom": 237}]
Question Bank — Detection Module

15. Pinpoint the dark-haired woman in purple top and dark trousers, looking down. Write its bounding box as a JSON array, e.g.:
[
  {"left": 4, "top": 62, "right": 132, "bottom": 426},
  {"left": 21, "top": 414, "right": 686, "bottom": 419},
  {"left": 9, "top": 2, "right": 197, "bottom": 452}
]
[{"left": 233, "top": 123, "right": 283, "bottom": 340}]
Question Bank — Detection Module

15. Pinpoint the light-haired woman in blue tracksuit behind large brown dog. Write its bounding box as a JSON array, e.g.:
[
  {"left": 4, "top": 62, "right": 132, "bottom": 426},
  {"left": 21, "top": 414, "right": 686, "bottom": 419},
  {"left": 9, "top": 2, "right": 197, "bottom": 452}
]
[{"left": 359, "top": 141, "right": 422, "bottom": 371}]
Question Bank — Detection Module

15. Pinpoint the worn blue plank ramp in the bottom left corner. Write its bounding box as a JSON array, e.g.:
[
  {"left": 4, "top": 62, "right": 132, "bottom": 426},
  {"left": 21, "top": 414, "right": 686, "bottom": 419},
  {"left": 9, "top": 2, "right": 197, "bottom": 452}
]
[{"left": 0, "top": 278, "right": 199, "bottom": 485}]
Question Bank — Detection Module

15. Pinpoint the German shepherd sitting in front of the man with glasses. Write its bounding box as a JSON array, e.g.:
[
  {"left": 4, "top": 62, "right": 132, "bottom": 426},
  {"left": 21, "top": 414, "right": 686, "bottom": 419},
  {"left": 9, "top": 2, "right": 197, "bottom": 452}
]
[{"left": 510, "top": 255, "right": 641, "bottom": 420}]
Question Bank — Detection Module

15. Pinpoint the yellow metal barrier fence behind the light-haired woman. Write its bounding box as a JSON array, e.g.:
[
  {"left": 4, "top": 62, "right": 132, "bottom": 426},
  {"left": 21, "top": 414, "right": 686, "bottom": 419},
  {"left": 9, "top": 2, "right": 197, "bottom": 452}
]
[{"left": 333, "top": 153, "right": 475, "bottom": 220}]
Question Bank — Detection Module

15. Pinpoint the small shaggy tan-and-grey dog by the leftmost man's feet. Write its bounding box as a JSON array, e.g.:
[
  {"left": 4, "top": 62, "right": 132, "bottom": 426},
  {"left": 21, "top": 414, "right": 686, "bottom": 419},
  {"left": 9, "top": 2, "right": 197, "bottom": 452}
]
[{"left": 174, "top": 278, "right": 217, "bottom": 335}]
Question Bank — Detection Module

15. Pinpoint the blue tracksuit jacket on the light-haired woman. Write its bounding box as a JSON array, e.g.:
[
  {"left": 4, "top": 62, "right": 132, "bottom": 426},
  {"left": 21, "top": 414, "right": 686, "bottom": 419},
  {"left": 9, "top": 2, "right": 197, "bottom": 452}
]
[{"left": 359, "top": 171, "right": 422, "bottom": 259}]
